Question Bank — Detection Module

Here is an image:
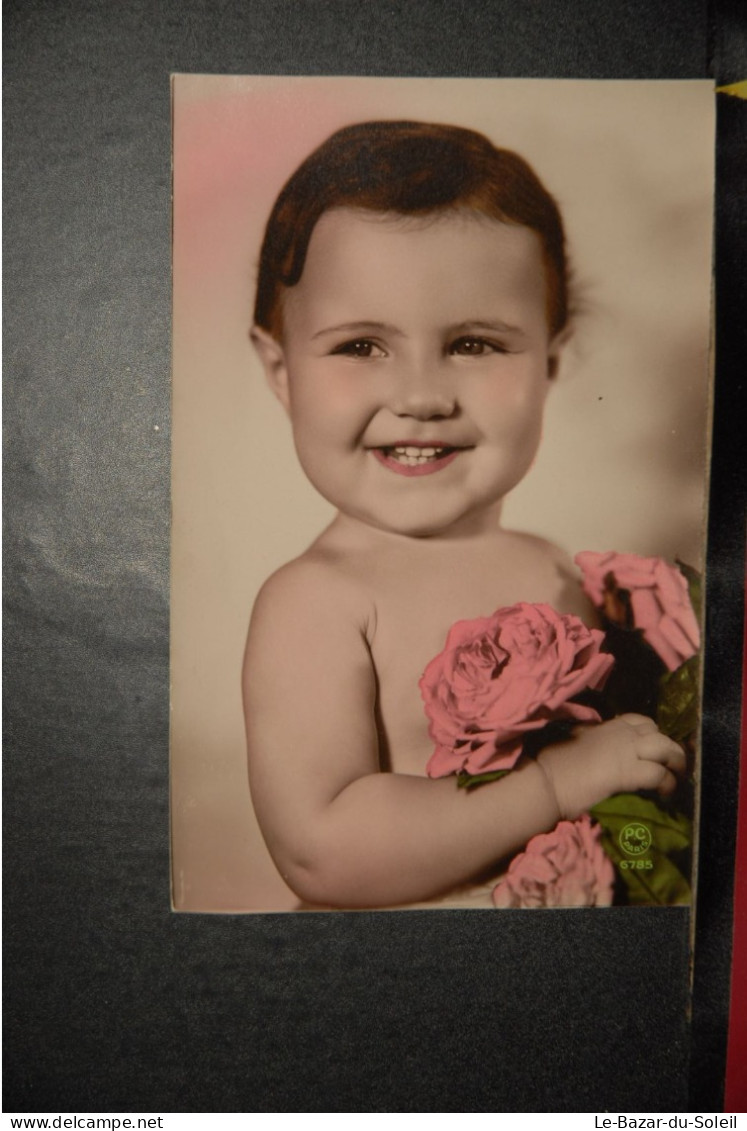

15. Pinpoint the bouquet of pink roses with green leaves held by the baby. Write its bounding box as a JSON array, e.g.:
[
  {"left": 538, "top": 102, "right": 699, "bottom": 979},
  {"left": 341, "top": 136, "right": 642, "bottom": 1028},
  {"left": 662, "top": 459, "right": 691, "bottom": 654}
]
[{"left": 420, "top": 552, "right": 699, "bottom": 907}]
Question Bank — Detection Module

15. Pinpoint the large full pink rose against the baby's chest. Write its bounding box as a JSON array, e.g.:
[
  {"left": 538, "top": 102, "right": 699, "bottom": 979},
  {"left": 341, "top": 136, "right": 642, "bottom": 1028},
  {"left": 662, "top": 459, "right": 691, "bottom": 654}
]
[{"left": 420, "top": 603, "right": 613, "bottom": 777}]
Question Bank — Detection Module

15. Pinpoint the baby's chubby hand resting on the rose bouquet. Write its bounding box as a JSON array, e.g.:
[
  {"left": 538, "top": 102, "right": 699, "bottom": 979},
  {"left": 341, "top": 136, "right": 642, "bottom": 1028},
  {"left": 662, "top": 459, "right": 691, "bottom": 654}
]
[{"left": 538, "top": 715, "right": 685, "bottom": 820}]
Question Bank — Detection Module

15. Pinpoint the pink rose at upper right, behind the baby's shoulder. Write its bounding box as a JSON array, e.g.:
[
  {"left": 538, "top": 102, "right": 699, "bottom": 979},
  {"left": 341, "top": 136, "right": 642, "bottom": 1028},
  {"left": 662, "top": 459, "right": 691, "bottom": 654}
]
[{"left": 575, "top": 551, "right": 701, "bottom": 672}]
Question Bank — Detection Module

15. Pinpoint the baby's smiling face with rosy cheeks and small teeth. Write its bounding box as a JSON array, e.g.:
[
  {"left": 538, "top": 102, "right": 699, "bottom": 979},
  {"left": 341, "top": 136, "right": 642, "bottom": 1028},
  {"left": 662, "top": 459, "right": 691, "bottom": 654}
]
[{"left": 264, "top": 209, "right": 558, "bottom": 536}]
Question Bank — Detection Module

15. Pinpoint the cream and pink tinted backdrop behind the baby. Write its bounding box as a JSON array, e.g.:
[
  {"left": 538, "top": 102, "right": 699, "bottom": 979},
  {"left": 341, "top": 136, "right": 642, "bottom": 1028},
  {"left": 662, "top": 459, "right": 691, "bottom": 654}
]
[{"left": 171, "top": 76, "right": 713, "bottom": 912}]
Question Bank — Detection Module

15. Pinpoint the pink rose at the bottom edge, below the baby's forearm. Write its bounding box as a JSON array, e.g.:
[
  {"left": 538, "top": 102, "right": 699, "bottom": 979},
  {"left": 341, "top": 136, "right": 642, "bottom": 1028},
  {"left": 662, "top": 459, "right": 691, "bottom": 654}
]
[{"left": 492, "top": 813, "right": 615, "bottom": 907}]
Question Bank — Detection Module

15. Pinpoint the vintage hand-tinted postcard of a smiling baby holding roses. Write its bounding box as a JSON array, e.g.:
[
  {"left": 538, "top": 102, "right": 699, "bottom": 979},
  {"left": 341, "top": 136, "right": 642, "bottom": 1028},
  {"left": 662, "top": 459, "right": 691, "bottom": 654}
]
[{"left": 171, "top": 75, "right": 714, "bottom": 914}]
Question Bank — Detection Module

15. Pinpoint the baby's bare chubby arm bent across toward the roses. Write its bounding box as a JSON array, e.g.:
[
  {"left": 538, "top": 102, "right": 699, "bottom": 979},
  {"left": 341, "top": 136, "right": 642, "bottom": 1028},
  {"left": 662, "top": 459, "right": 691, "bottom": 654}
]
[{"left": 244, "top": 561, "right": 681, "bottom": 907}]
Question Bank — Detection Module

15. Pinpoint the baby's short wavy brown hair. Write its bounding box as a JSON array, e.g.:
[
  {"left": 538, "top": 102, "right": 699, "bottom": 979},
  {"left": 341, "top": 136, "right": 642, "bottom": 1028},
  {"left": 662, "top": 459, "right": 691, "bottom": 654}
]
[{"left": 255, "top": 121, "right": 568, "bottom": 337}]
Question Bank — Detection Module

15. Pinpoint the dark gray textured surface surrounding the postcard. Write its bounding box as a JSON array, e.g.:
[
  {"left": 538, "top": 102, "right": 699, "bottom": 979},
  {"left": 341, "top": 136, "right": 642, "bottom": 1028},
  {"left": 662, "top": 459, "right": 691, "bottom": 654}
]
[{"left": 5, "top": 0, "right": 745, "bottom": 1112}]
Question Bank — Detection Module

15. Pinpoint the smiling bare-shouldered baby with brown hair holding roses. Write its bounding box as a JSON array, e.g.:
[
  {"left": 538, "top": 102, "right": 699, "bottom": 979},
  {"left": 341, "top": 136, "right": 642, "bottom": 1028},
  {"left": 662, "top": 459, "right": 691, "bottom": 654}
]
[{"left": 243, "top": 121, "right": 684, "bottom": 907}]
